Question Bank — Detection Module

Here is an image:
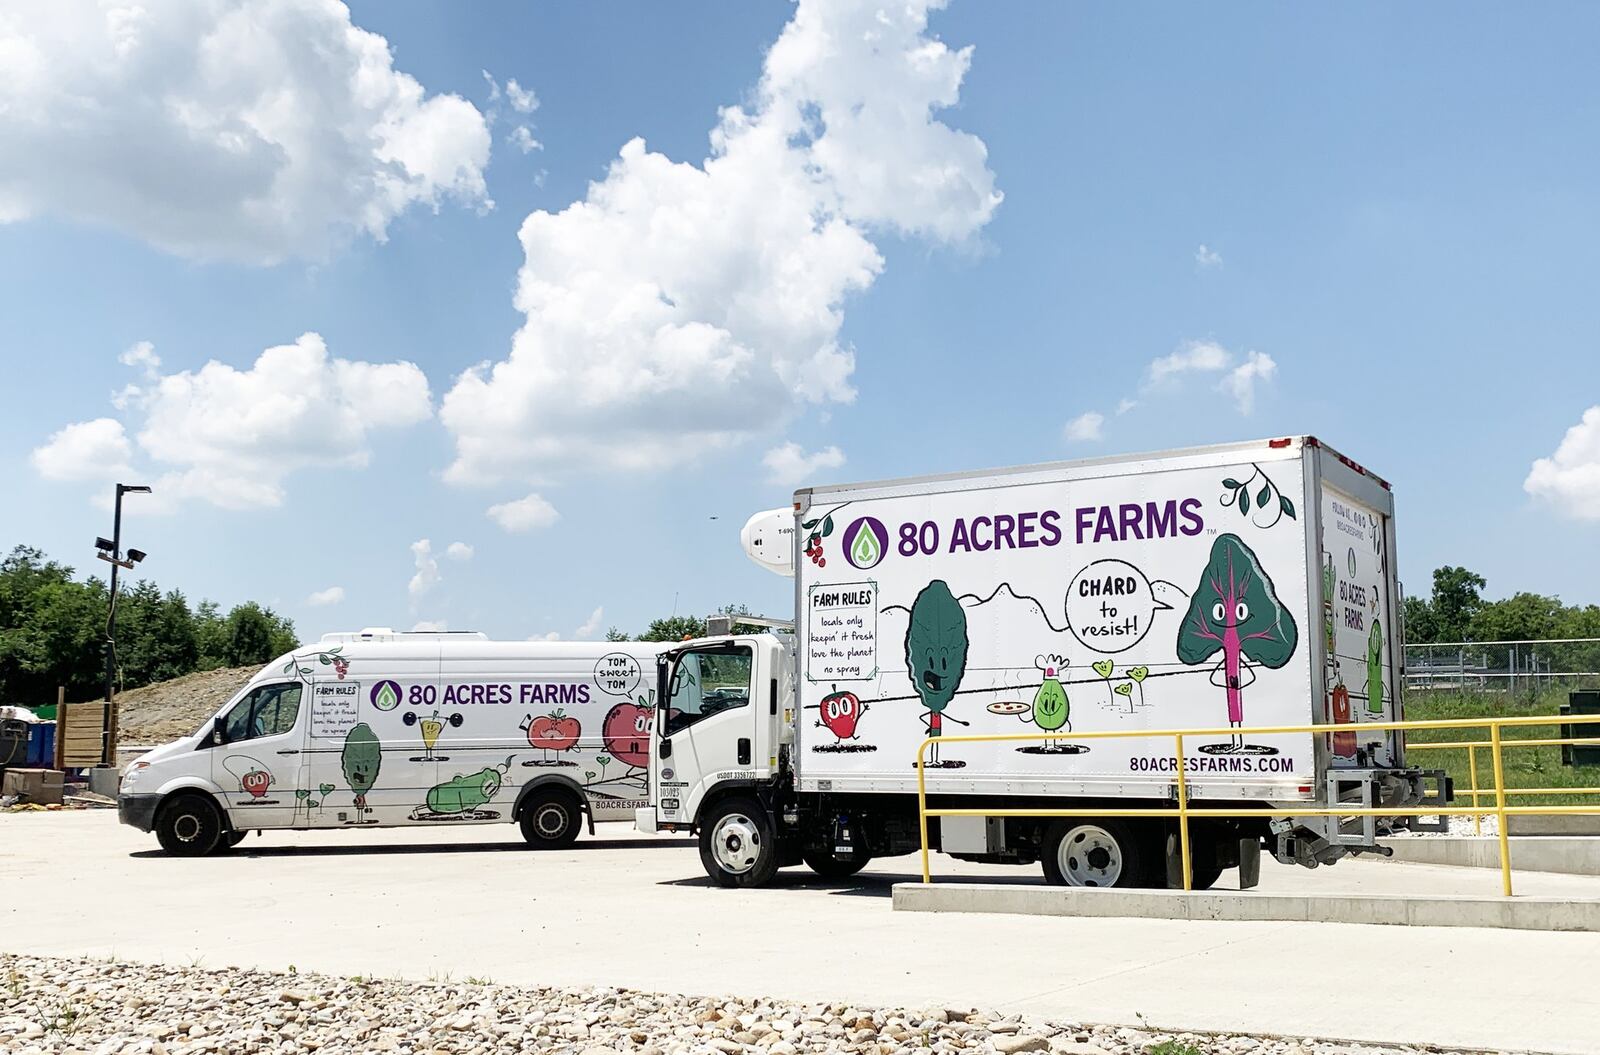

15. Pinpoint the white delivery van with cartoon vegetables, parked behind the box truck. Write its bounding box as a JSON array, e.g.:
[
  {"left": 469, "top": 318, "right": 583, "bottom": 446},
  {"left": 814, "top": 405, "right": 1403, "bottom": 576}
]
[{"left": 118, "top": 629, "right": 666, "bottom": 855}]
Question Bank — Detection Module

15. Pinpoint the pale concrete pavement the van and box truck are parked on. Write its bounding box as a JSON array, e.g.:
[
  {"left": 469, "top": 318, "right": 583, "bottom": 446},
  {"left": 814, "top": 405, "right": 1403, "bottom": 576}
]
[{"left": 0, "top": 812, "right": 1600, "bottom": 1053}]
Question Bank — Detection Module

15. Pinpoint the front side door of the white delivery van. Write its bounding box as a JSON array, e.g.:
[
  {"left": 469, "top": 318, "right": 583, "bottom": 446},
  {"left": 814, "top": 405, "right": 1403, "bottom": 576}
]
[{"left": 208, "top": 680, "right": 306, "bottom": 831}]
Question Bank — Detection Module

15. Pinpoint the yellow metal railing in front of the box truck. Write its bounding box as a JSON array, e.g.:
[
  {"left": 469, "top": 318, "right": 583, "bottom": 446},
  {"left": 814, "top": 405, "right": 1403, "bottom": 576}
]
[{"left": 917, "top": 714, "right": 1600, "bottom": 897}]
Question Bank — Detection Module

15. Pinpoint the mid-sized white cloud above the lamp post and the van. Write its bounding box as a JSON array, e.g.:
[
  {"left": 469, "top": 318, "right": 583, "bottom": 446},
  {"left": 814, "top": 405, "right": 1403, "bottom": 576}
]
[{"left": 34, "top": 333, "right": 434, "bottom": 509}]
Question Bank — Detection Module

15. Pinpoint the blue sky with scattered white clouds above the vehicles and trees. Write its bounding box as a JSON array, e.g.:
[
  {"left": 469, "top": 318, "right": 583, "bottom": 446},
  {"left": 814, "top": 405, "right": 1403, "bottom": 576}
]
[{"left": 0, "top": 0, "right": 1600, "bottom": 637}]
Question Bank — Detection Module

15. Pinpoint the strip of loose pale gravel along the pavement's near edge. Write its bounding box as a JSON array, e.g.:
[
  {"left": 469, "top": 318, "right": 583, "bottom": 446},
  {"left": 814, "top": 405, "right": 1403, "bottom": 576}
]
[{"left": 0, "top": 956, "right": 1536, "bottom": 1055}]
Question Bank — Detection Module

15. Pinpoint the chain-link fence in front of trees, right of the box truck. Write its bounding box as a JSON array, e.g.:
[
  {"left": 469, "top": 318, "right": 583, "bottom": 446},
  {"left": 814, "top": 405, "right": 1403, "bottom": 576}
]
[{"left": 1405, "top": 637, "right": 1600, "bottom": 700}]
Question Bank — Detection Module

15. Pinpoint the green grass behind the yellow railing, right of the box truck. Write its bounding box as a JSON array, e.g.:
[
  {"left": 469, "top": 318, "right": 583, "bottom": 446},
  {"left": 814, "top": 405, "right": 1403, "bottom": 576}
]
[{"left": 1405, "top": 692, "right": 1600, "bottom": 807}]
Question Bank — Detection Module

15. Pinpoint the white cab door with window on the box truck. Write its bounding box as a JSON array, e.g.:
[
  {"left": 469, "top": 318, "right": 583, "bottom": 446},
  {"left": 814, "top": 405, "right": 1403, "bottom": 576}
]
[{"left": 654, "top": 640, "right": 768, "bottom": 824}]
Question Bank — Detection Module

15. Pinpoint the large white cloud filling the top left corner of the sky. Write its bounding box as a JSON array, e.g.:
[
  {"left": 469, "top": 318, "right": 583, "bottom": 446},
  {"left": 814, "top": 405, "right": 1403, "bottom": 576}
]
[{"left": 0, "top": 0, "right": 490, "bottom": 263}]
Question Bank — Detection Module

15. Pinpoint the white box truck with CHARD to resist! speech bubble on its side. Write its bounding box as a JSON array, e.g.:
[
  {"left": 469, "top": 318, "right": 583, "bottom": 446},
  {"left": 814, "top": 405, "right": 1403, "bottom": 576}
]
[{"left": 637, "top": 437, "right": 1450, "bottom": 887}]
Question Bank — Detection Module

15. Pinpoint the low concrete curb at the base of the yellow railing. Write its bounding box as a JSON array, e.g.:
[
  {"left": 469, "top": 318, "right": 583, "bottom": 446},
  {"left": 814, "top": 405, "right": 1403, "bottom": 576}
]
[{"left": 894, "top": 882, "right": 1600, "bottom": 930}]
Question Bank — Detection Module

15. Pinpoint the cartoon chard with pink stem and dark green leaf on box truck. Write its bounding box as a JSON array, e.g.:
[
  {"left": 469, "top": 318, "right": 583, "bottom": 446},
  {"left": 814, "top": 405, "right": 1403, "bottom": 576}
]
[{"left": 1178, "top": 535, "right": 1299, "bottom": 754}]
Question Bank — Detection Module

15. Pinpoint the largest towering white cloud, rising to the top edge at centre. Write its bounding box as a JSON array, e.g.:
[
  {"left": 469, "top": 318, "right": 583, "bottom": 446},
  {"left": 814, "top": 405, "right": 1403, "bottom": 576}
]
[{"left": 440, "top": 0, "right": 1002, "bottom": 482}]
